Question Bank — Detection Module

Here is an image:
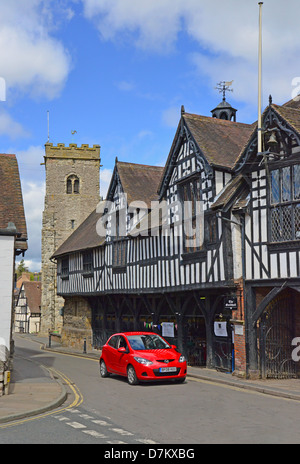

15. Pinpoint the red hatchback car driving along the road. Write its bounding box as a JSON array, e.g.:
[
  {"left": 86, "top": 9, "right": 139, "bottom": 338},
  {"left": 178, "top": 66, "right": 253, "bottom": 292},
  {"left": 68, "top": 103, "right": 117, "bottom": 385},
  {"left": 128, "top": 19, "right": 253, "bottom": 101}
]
[{"left": 100, "top": 332, "right": 187, "bottom": 385}]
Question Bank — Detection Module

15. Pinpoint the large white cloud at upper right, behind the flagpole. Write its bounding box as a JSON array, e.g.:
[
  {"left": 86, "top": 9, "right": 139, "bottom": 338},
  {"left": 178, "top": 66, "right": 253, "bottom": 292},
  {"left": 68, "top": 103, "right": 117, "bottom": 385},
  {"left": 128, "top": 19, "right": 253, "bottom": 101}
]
[{"left": 82, "top": 0, "right": 300, "bottom": 104}]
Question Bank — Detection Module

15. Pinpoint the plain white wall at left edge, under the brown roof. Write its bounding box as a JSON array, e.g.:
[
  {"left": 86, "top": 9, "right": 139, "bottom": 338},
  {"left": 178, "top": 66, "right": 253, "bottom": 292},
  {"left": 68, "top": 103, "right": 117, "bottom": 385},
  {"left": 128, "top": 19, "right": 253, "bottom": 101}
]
[{"left": 0, "top": 235, "right": 15, "bottom": 362}]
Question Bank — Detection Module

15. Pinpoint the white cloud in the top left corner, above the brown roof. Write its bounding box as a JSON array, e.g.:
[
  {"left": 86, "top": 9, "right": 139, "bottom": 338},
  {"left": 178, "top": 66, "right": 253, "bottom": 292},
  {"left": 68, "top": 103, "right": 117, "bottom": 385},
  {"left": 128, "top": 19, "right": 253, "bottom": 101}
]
[{"left": 0, "top": 0, "right": 71, "bottom": 98}]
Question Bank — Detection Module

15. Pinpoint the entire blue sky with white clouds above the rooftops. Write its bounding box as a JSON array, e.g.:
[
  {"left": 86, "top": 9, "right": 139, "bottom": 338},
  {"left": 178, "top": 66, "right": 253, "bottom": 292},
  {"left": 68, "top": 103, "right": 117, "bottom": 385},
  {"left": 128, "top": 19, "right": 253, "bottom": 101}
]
[{"left": 0, "top": 0, "right": 300, "bottom": 271}]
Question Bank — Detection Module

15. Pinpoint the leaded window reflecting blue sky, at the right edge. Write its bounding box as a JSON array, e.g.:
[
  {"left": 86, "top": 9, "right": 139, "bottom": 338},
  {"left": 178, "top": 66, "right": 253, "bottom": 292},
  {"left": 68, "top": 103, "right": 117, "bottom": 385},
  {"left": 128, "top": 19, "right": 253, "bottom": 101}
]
[{"left": 270, "top": 164, "right": 300, "bottom": 242}]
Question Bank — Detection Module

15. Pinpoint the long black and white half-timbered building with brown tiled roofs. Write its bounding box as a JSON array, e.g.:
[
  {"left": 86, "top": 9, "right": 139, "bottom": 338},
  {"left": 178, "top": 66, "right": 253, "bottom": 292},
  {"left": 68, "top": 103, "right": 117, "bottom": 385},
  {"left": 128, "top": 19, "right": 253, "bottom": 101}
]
[{"left": 54, "top": 96, "right": 300, "bottom": 376}]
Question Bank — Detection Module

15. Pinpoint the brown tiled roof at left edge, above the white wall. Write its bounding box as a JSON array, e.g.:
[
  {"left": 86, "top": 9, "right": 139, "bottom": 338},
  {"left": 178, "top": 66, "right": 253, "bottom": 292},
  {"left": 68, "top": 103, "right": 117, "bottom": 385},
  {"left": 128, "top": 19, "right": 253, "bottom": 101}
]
[{"left": 0, "top": 154, "right": 27, "bottom": 249}]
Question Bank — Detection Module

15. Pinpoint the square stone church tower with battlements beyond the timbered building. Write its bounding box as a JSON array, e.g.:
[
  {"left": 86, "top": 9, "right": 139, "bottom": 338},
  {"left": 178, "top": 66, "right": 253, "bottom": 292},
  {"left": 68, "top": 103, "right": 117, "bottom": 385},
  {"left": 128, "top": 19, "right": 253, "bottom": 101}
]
[{"left": 41, "top": 143, "right": 100, "bottom": 334}]
